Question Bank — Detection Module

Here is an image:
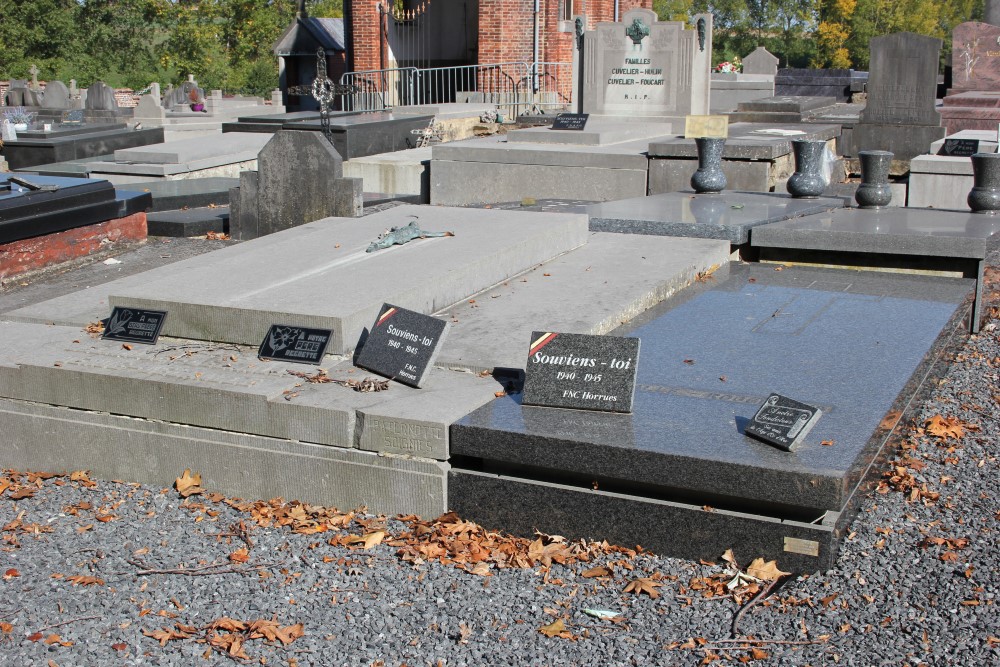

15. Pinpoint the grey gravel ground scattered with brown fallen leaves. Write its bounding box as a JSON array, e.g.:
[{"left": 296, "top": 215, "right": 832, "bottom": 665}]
[{"left": 0, "top": 240, "right": 1000, "bottom": 667}]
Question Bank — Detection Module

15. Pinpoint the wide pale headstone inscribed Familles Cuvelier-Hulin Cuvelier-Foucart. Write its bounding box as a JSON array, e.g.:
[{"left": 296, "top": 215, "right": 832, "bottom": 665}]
[{"left": 583, "top": 9, "right": 712, "bottom": 118}]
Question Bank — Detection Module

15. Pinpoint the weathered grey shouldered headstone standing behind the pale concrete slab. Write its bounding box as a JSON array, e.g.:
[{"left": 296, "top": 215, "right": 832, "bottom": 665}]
[{"left": 230, "top": 130, "right": 362, "bottom": 240}]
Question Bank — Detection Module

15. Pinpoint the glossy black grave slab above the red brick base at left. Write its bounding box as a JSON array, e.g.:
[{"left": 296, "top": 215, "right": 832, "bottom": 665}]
[{"left": 0, "top": 174, "right": 119, "bottom": 243}]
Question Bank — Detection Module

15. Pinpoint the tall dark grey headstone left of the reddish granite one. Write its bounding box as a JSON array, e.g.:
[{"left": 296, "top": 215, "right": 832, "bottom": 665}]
[{"left": 851, "top": 32, "right": 944, "bottom": 160}]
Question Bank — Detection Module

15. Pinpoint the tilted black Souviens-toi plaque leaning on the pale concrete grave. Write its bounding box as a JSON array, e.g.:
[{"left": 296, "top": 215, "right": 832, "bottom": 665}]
[{"left": 357, "top": 303, "right": 448, "bottom": 387}]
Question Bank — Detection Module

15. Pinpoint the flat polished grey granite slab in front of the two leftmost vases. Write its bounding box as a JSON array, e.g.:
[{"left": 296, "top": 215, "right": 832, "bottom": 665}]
[{"left": 587, "top": 191, "right": 843, "bottom": 249}]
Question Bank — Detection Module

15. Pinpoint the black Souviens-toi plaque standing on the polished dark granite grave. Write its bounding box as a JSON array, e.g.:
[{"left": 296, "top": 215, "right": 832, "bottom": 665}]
[{"left": 522, "top": 331, "right": 639, "bottom": 412}]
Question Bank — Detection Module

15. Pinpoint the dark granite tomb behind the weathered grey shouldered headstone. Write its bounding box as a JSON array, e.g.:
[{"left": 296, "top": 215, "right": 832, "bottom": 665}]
[{"left": 222, "top": 111, "right": 434, "bottom": 160}]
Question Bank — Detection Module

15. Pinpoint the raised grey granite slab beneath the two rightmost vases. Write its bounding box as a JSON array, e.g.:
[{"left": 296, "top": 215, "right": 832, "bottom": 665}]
[{"left": 751, "top": 208, "right": 1000, "bottom": 332}]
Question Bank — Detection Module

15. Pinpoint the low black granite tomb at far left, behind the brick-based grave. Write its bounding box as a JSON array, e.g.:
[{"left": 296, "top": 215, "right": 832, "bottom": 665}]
[{"left": 0, "top": 125, "right": 163, "bottom": 170}]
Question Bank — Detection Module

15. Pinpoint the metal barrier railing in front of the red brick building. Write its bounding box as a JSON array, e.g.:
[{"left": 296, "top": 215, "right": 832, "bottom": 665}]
[{"left": 340, "top": 62, "right": 573, "bottom": 118}]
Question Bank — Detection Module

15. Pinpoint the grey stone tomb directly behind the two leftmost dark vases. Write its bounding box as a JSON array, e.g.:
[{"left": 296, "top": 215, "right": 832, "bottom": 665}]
[{"left": 649, "top": 123, "right": 840, "bottom": 194}]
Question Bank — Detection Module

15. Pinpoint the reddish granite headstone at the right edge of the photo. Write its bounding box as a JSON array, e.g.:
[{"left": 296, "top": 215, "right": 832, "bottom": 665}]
[{"left": 941, "top": 21, "right": 1000, "bottom": 134}]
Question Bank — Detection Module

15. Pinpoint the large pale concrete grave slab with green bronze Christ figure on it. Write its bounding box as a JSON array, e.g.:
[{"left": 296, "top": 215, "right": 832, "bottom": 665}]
[{"left": 6, "top": 206, "right": 587, "bottom": 354}]
